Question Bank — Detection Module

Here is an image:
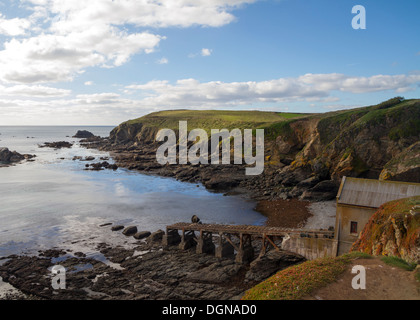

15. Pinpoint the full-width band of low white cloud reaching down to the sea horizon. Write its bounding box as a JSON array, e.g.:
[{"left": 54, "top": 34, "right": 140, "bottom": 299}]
[{"left": 0, "top": 73, "right": 420, "bottom": 125}]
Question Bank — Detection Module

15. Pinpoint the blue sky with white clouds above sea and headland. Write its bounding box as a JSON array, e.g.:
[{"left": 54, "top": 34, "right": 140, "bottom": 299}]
[{"left": 0, "top": 0, "right": 420, "bottom": 125}]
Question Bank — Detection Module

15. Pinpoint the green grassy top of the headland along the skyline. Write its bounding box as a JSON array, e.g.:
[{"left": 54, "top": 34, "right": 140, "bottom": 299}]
[{"left": 120, "top": 98, "right": 420, "bottom": 145}]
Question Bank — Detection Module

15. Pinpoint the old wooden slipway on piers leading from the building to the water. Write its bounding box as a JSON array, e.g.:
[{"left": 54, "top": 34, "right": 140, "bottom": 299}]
[{"left": 163, "top": 222, "right": 334, "bottom": 263}]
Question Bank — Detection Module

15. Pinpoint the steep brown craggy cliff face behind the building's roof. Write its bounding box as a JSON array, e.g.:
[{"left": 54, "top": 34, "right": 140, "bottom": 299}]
[{"left": 272, "top": 100, "right": 420, "bottom": 183}]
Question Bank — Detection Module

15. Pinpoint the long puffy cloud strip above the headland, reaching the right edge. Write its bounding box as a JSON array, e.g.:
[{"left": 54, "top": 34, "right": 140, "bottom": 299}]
[{"left": 126, "top": 73, "right": 420, "bottom": 108}]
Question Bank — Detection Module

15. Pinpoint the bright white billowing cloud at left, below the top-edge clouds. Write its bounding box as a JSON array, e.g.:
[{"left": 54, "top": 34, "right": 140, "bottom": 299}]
[{"left": 0, "top": 26, "right": 161, "bottom": 83}]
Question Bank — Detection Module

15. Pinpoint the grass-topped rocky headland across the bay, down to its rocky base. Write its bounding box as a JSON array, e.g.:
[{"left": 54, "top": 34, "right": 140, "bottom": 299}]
[{"left": 97, "top": 97, "right": 420, "bottom": 200}]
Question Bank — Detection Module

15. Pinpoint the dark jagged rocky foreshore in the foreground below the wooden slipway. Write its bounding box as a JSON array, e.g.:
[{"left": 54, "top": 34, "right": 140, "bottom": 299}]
[{"left": 0, "top": 224, "right": 305, "bottom": 300}]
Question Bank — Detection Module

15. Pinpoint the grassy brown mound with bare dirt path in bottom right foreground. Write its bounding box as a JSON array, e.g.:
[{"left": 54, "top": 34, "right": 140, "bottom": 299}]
[{"left": 242, "top": 252, "right": 420, "bottom": 300}]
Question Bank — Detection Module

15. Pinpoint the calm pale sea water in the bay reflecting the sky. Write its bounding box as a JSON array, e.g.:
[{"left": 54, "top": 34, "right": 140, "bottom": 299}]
[{"left": 0, "top": 126, "right": 265, "bottom": 257}]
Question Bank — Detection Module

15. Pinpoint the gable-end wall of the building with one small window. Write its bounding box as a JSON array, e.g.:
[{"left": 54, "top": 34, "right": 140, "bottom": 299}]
[{"left": 335, "top": 204, "right": 377, "bottom": 255}]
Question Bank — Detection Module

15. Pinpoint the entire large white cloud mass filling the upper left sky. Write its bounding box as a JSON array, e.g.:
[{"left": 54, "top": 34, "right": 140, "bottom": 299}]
[{"left": 0, "top": 0, "right": 254, "bottom": 84}]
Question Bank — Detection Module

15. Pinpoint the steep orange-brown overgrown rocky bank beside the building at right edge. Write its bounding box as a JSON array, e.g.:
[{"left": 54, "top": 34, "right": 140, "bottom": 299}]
[{"left": 351, "top": 196, "right": 420, "bottom": 264}]
